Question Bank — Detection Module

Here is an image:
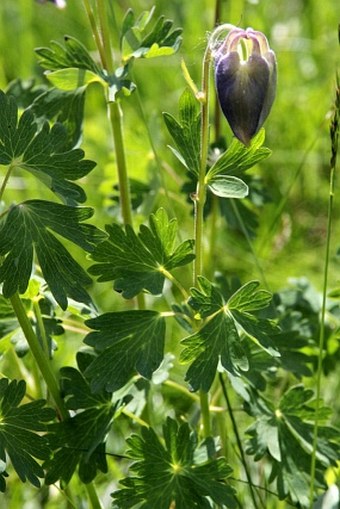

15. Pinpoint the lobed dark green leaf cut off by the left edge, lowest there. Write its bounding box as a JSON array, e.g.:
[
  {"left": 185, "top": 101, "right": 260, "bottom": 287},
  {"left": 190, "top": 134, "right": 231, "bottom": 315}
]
[{"left": 0, "top": 378, "right": 55, "bottom": 491}]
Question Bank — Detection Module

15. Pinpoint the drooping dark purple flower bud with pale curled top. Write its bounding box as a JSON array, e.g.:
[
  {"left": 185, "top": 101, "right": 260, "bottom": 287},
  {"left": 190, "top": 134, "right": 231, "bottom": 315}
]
[{"left": 214, "top": 27, "right": 277, "bottom": 145}]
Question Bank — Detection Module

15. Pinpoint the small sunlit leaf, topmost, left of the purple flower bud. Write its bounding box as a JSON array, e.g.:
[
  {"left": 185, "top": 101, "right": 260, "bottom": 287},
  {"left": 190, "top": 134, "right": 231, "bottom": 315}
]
[{"left": 121, "top": 8, "right": 182, "bottom": 62}]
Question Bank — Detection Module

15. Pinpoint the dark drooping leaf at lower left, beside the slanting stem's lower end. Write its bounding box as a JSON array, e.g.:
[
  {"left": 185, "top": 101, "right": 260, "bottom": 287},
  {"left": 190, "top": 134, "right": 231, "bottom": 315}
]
[{"left": 43, "top": 367, "right": 120, "bottom": 484}]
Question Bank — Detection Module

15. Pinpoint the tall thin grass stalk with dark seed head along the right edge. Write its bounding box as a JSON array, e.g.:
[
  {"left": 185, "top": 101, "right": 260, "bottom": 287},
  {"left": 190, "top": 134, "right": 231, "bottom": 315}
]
[{"left": 309, "top": 77, "right": 340, "bottom": 509}]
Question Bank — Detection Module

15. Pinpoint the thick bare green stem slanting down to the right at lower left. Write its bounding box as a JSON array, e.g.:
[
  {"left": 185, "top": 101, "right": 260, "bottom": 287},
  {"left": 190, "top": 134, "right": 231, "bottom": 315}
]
[{"left": 10, "top": 293, "right": 69, "bottom": 419}]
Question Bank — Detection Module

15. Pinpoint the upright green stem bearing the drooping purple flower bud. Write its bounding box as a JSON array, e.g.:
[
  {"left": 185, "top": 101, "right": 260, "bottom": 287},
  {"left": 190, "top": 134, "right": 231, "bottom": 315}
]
[{"left": 193, "top": 41, "right": 211, "bottom": 437}]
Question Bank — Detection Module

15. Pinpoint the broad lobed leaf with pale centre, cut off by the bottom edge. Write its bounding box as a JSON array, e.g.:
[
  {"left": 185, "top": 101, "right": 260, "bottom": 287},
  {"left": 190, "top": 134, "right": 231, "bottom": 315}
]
[{"left": 112, "top": 418, "right": 236, "bottom": 509}]
